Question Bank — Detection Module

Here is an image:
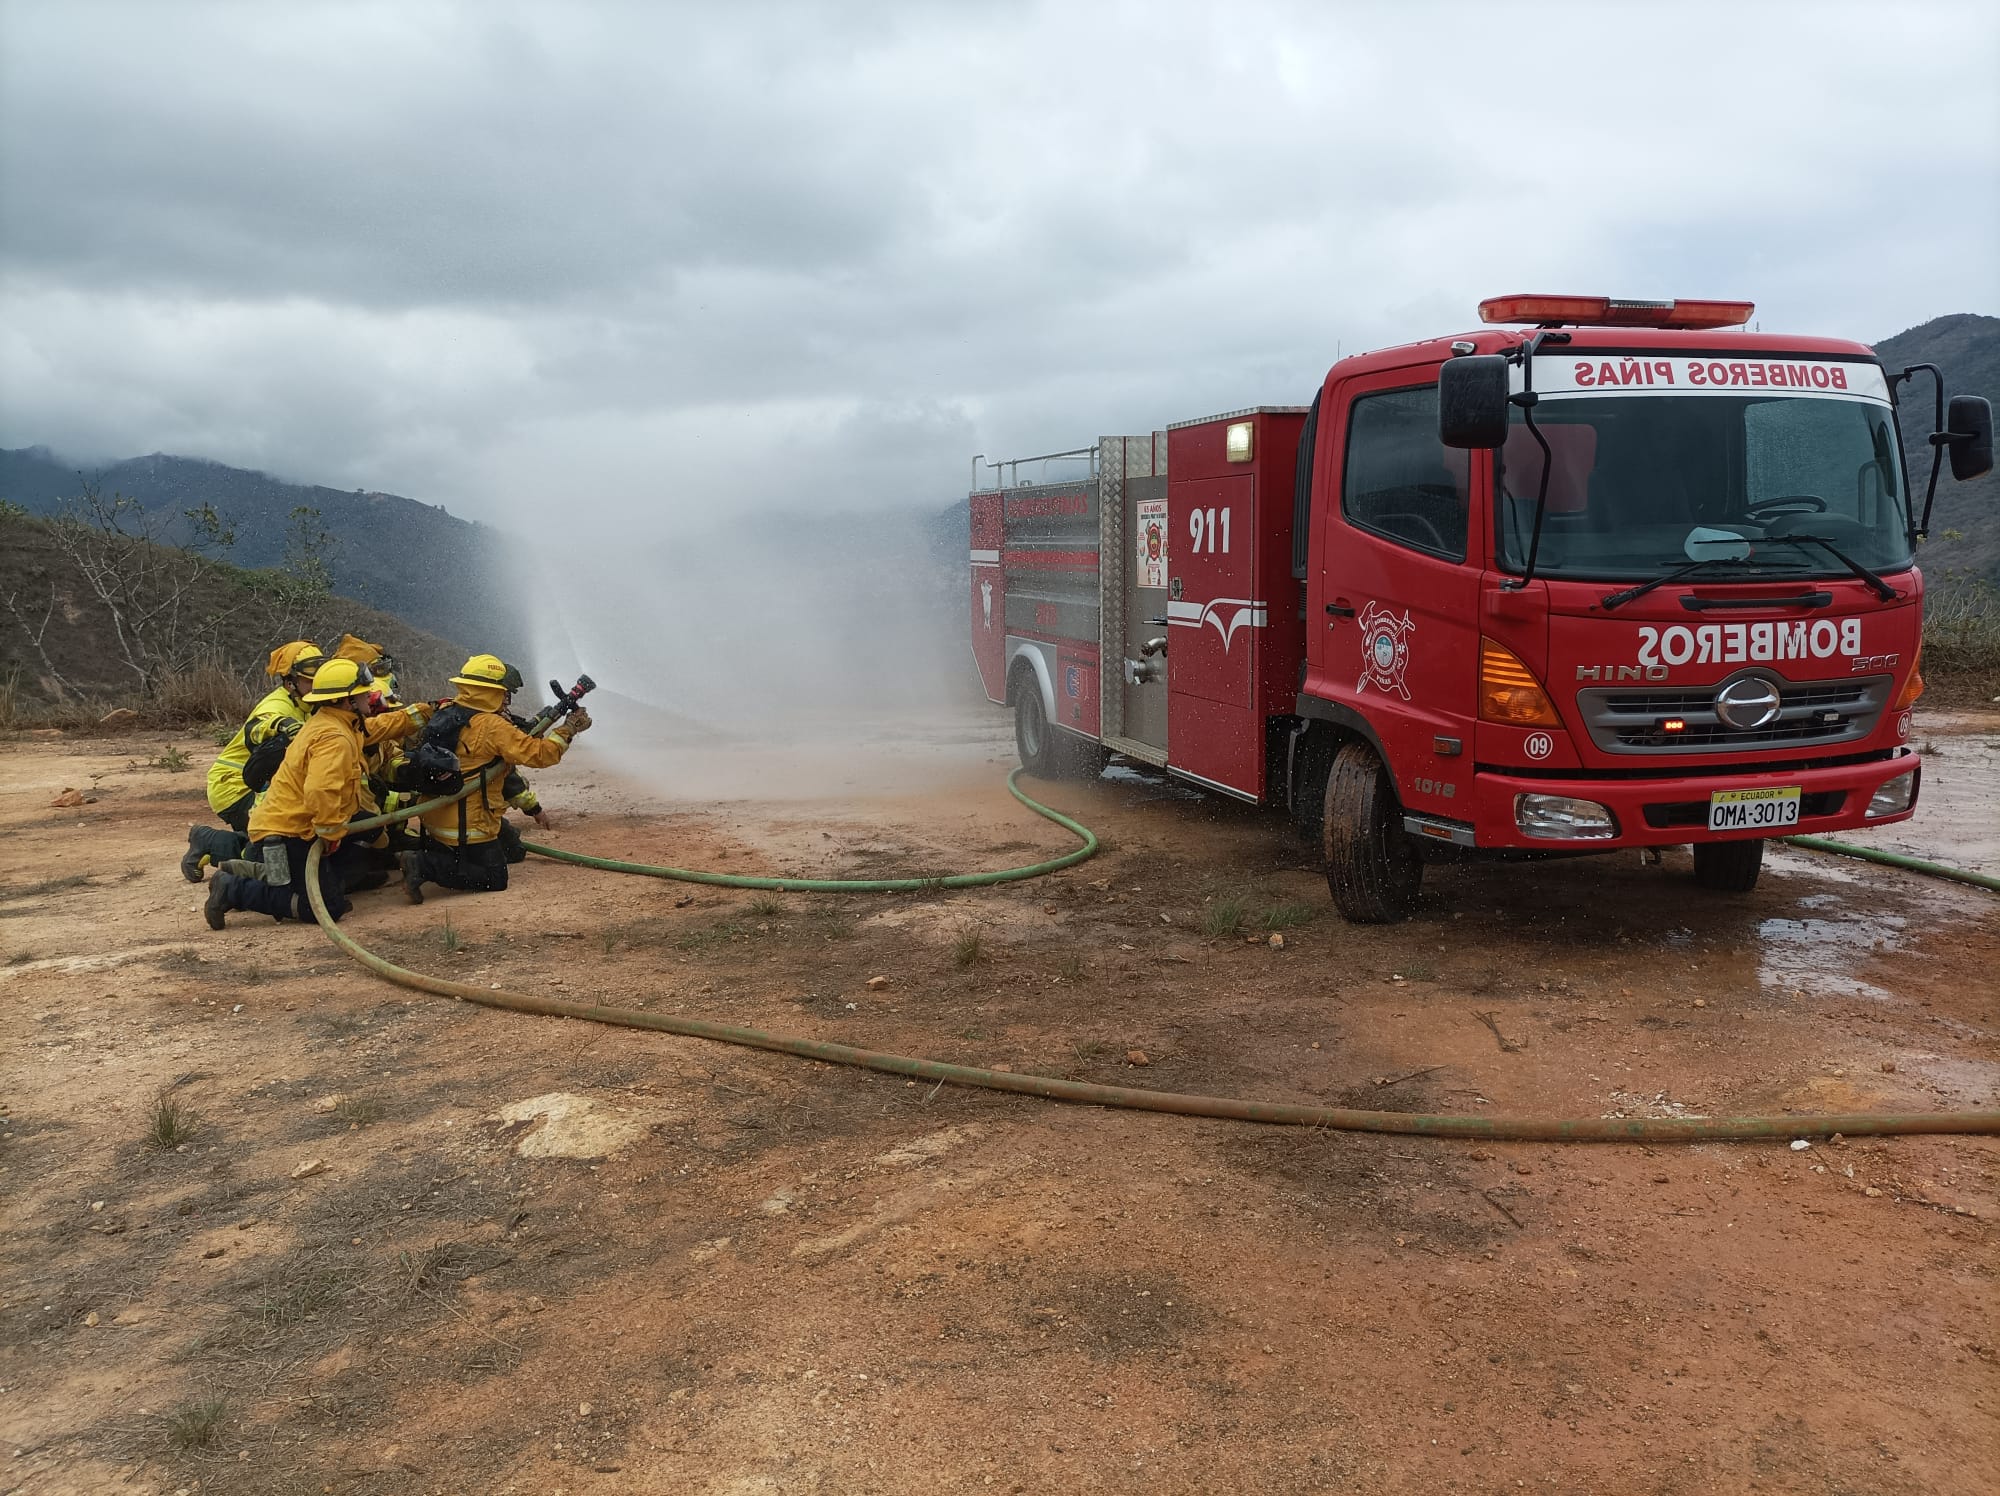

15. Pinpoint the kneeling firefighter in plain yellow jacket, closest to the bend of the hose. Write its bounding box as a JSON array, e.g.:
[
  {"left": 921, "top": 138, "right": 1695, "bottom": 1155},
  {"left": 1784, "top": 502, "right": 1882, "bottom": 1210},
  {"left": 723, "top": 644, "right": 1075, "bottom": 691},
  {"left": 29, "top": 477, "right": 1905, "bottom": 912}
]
[{"left": 202, "top": 660, "right": 428, "bottom": 930}]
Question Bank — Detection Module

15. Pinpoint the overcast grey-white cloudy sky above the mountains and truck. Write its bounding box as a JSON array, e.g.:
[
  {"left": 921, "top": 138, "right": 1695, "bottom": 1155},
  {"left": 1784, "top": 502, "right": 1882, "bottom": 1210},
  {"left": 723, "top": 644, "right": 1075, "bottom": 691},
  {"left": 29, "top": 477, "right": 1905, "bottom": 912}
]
[{"left": 0, "top": 0, "right": 2000, "bottom": 524}]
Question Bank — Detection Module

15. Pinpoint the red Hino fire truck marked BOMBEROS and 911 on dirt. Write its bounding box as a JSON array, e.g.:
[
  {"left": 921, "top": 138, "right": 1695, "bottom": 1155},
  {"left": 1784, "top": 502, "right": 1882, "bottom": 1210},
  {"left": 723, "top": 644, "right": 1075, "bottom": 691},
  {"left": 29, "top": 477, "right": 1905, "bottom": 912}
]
[{"left": 970, "top": 296, "right": 1992, "bottom": 922}]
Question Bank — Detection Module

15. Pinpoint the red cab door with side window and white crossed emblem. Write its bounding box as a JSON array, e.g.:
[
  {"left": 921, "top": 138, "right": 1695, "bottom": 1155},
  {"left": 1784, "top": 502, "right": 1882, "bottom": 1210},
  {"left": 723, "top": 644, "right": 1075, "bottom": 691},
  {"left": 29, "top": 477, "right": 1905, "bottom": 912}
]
[{"left": 1304, "top": 366, "right": 1486, "bottom": 820}]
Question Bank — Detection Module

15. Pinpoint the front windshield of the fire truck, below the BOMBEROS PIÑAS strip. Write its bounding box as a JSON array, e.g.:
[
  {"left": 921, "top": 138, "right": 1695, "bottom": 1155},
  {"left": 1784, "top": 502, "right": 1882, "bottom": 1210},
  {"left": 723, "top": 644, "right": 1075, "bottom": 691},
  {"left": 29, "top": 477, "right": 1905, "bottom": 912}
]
[{"left": 1494, "top": 394, "right": 1912, "bottom": 582}]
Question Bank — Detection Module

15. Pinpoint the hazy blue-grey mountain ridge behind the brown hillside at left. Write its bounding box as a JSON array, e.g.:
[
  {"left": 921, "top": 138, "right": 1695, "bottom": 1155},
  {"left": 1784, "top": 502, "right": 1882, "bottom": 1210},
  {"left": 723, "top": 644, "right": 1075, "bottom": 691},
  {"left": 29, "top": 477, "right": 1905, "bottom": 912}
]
[{"left": 0, "top": 446, "right": 526, "bottom": 658}]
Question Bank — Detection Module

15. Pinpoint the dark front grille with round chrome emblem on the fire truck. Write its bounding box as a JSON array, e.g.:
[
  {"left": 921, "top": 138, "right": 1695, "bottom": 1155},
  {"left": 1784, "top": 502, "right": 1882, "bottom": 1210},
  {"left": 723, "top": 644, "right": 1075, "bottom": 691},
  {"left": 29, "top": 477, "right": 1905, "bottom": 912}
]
[{"left": 1576, "top": 670, "right": 1896, "bottom": 754}]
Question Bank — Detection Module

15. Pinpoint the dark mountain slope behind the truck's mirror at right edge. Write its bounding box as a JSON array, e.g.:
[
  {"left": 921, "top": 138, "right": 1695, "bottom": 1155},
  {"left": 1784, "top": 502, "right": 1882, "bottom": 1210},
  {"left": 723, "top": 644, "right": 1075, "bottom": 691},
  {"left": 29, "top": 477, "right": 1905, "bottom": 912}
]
[{"left": 1876, "top": 312, "right": 2000, "bottom": 584}]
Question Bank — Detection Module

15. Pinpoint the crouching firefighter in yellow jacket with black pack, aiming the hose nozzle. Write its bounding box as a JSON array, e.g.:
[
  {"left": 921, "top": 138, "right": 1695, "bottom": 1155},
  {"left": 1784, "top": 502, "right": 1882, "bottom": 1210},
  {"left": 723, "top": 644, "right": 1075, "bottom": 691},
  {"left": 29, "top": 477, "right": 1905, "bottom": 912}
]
[{"left": 402, "top": 654, "right": 590, "bottom": 904}]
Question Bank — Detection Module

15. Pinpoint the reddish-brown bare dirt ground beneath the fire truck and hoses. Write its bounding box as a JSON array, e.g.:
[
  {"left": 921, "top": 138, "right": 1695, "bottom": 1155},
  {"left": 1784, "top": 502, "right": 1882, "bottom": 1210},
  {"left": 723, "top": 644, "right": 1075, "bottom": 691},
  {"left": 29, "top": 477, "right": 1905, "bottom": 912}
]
[{"left": 0, "top": 716, "right": 2000, "bottom": 1496}]
